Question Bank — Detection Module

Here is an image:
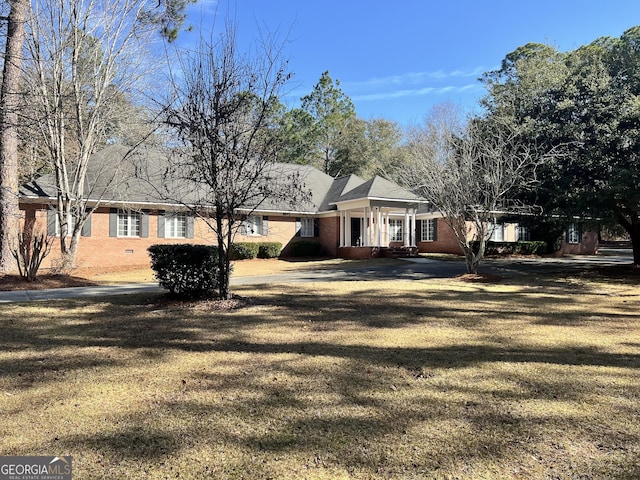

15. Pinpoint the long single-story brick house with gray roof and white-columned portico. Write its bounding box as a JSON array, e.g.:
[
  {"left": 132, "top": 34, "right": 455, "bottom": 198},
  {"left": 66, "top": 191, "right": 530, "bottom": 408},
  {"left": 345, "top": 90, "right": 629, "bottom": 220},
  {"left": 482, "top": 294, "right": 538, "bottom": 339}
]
[{"left": 20, "top": 145, "right": 600, "bottom": 268}]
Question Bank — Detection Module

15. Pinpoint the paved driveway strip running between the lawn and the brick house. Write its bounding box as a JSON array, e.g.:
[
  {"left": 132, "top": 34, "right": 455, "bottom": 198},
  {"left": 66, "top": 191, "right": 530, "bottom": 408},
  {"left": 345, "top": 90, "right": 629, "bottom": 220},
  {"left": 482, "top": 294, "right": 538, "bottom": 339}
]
[{"left": 0, "top": 250, "right": 633, "bottom": 304}]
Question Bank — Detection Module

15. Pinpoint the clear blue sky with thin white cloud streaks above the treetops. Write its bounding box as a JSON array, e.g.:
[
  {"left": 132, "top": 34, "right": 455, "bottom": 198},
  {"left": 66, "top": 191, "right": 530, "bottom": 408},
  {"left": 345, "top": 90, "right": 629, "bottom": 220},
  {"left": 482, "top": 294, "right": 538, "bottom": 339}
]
[{"left": 180, "top": 0, "right": 640, "bottom": 125}]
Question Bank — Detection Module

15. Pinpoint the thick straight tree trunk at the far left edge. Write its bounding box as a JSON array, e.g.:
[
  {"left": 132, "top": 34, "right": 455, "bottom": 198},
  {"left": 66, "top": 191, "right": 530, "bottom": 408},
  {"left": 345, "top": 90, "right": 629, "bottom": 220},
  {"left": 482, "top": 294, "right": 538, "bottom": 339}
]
[{"left": 0, "top": 0, "right": 31, "bottom": 272}]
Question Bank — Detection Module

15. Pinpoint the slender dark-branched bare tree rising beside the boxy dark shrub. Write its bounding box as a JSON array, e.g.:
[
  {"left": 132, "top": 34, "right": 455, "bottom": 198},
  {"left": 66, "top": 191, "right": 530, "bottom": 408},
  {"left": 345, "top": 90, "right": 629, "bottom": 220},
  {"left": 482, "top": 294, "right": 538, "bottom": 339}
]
[{"left": 160, "top": 21, "right": 305, "bottom": 299}]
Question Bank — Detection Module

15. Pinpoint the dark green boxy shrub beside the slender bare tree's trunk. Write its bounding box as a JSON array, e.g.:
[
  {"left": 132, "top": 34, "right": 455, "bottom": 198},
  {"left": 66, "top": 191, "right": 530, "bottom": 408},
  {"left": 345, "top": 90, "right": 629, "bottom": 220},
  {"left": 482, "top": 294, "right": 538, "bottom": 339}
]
[{"left": 147, "top": 244, "right": 218, "bottom": 298}]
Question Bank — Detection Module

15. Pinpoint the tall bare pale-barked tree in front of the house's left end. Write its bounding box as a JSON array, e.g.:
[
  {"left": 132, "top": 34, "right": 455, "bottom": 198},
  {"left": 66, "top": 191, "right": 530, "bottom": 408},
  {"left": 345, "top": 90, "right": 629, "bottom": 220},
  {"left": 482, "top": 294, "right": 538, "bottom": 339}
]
[{"left": 25, "top": 0, "right": 164, "bottom": 269}]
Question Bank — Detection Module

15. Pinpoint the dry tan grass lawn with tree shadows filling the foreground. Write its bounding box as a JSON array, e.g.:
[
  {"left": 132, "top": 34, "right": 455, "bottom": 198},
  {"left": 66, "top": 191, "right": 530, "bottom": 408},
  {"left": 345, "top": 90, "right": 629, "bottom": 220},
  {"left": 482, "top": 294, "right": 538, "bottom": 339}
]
[{"left": 0, "top": 268, "right": 640, "bottom": 479}]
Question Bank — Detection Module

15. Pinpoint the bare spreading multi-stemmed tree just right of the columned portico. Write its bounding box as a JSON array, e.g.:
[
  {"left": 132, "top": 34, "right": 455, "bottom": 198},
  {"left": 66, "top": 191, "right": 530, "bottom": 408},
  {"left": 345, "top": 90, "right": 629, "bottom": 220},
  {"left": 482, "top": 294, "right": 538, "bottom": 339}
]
[{"left": 398, "top": 105, "right": 543, "bottom": 273}]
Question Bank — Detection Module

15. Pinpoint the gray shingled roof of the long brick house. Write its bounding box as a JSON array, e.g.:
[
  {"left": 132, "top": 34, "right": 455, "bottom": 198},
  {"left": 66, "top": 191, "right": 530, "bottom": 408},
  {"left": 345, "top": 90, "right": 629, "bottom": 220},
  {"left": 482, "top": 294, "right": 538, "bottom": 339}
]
[{"left": 20, "top": 145, "right": 420, "bottom": 213}]
